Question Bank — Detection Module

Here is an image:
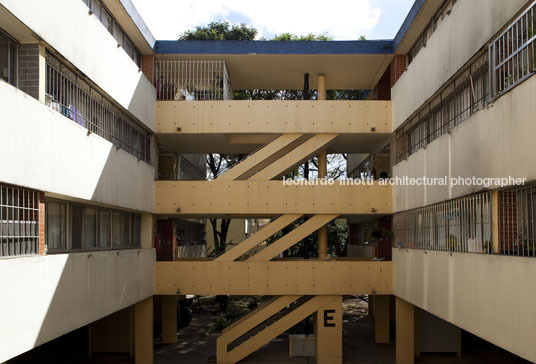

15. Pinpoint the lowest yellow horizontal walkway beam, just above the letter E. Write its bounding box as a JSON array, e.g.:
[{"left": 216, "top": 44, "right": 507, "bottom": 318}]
[{"left": 155, "top": 259, "right": 393, "bottom": 295}]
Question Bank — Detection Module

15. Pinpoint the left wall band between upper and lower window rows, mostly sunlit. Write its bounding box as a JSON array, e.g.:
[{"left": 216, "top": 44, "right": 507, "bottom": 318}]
[{"left": 0, "top": 82, "right": 154, "bottom": 212}]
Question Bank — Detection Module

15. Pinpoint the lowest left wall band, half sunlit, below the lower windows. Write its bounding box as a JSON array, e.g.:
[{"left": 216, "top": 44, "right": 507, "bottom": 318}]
[{"left": 0, "top": 249, "right": 155, "bottom": 362}]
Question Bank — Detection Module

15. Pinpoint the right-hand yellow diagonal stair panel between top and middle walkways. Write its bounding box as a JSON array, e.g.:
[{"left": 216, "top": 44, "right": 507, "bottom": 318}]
[{"left": 250, "top": 134, "right": 339, "bottom": 181}]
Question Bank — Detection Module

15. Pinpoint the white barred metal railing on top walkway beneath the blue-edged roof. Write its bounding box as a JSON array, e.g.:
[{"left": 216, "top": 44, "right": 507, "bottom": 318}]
[{"left": 154, "top": 60, "right": 233, "bottom": 101}]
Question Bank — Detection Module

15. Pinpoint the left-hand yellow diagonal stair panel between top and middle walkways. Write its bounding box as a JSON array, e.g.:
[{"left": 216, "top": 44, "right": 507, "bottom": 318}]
[{"left": 218, "top": 134, "right": 303, "bottom": 181}]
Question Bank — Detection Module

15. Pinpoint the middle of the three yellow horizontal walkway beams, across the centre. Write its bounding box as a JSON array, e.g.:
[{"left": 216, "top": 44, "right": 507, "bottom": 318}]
[{"left": 155, "top": 180, "right": 392, "bottom": 216}]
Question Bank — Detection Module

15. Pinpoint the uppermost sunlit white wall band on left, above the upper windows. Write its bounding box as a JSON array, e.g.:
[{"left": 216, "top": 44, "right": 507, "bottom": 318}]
[{"left": 0, "top": 0, "right": 156, "bottom": 130}]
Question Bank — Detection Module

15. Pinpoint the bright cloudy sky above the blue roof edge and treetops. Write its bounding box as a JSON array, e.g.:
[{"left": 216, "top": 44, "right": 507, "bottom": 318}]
[{"left": 131, "top": 0, "right": 414, "bottom": 40}]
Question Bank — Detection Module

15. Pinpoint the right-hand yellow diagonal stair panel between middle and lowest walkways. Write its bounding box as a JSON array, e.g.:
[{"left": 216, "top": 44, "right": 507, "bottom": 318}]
[{"left": 248, "top": 215, "right": 337, "bottom": 262}]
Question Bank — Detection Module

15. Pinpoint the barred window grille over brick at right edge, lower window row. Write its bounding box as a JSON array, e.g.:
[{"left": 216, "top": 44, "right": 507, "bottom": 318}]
[{"left": 498, "top": 184, "right": 536, "bottom": 257}]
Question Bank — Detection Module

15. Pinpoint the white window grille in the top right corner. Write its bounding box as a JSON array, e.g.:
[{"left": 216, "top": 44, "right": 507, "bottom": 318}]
[{"left": 489, "top": 1, "right": 536, "bottom": 97}]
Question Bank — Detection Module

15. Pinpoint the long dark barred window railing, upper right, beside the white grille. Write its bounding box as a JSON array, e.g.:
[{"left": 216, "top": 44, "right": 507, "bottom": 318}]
[{"left": 395, "top": 55, "right": 489, "bottom": 163}]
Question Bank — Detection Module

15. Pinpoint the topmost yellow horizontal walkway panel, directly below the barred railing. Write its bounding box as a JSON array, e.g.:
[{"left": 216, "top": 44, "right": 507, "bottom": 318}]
[{"left": 156, "top": 100, "right": 392, "bottom": 134}]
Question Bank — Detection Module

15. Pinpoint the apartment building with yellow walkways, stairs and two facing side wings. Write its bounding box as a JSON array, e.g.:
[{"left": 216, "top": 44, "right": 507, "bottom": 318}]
[{"left": 0, "top": 0, "right": 536, "bottom": 364}]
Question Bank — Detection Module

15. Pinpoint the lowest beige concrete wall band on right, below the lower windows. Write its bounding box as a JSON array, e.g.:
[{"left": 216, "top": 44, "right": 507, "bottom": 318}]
[{"left": 393, "top": 248, "right": 536, "bottom": 361}]
